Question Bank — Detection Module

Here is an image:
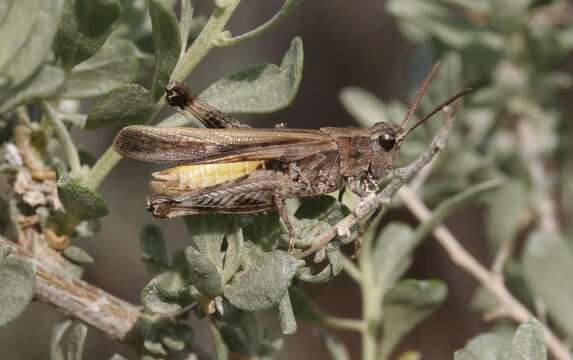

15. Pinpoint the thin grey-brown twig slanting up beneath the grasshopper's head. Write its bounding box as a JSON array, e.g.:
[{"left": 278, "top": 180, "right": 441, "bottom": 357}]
[{"left": 300, "top": 107, "right": 456, "bottom": 258}]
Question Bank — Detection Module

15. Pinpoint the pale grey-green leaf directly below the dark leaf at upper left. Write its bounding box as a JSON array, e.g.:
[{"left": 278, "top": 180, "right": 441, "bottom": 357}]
[{"left": 62, "top": 38, "right": 140, "bottom": 99}]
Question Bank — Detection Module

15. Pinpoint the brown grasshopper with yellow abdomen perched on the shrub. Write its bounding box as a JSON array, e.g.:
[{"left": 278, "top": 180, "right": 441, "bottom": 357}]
[{"left": 114, "top": 64, "right": 470, "bottom": 249}]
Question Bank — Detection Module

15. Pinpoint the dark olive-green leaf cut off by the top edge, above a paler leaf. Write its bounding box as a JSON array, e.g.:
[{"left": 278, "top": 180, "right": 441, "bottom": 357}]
[{"left": 54, "top": 0, "right": 121, "bottom": 69}]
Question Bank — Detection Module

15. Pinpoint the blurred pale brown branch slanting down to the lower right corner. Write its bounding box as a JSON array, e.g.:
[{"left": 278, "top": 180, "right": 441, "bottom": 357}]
[{"left": 398, "top": 187, "right": 571, "bottom": 360}]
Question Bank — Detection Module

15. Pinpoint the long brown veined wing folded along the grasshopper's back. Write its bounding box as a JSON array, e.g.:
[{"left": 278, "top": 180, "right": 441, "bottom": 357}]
[{"left": 113, "top": 125, "right": 337, "bottom": 164}]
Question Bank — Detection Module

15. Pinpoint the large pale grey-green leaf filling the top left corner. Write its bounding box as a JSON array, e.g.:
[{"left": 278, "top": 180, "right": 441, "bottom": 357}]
[{"left": 0, "top": 0, "right": 64, "bottom": 88}]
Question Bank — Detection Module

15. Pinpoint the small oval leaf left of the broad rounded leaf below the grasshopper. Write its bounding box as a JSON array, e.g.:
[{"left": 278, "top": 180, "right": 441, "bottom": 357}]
[{"left": 185, "top": 246, "right": 223, "bottom": 296}]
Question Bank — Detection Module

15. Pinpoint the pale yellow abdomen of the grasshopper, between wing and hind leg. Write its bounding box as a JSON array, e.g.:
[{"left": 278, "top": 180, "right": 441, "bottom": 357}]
[{"left": 150, "top": 161, "right": 265, "bottom": 195}]
